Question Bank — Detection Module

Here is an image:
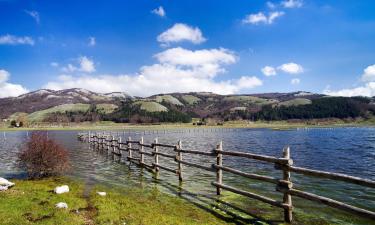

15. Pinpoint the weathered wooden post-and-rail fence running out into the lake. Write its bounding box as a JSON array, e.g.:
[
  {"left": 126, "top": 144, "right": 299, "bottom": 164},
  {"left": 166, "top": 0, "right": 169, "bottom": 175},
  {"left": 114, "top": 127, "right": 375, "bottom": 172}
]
[{"left": 78, "top": 132, "right": 375, "bottom": 222}]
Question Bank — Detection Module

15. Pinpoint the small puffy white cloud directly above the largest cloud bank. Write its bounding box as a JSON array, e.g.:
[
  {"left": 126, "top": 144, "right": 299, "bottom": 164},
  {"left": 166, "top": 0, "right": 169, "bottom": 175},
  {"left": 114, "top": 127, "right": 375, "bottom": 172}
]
[{"left": 157, "top": 23, "right": 206, "bottom": 45}]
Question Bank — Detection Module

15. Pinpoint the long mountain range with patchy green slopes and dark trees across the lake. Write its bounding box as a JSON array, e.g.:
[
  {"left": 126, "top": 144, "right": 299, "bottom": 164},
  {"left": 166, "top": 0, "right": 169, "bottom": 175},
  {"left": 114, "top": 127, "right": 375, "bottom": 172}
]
[{"left": 0, "top": 88, "right": 375, "bottom": 123}]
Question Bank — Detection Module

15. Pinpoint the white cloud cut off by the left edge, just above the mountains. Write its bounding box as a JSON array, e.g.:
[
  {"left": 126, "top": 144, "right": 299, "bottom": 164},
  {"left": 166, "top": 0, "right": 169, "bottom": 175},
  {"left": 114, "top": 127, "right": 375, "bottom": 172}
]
[{"left": 0, "top": 69, "right": 28, "bottom": 98}]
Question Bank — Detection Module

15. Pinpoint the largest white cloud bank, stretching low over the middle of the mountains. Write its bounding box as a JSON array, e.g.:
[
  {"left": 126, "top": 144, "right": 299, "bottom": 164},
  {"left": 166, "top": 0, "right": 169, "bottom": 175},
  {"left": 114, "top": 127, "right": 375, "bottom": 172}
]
[{"left": 45, "top": 48, "right": 262, "bottom": 96}]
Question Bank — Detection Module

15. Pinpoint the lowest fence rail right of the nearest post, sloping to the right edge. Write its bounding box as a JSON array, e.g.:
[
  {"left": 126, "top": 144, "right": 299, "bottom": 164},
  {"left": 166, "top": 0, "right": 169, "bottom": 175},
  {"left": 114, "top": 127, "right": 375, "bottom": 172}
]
[{"left": 288, "top": 189, "right": 375, "bottom": 219}]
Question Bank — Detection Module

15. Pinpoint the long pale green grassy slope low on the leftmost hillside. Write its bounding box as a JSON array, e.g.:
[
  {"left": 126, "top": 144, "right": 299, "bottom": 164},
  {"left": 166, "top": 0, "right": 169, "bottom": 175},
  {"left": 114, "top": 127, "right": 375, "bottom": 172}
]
[{"left": 28, "top": 103, "right": 90, "bottom": 122}]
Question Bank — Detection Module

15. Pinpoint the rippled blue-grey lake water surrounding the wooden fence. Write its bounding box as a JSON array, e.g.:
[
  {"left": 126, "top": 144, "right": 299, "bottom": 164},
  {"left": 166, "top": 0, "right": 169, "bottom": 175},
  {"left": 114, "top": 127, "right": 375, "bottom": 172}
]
[{"left": 0, "top": 128, "right": 375, "bottom": 224}]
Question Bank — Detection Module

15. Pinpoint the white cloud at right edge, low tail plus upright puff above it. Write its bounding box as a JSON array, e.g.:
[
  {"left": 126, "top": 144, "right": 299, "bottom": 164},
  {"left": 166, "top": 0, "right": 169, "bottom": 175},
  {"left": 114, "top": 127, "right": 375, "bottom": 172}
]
[{"left": 323, "top": 64, "right": 375, "bottom": 97}]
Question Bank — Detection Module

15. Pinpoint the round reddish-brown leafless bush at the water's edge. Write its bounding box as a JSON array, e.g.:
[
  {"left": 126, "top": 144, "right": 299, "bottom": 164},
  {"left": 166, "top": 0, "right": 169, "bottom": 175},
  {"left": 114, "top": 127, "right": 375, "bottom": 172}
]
[{"left": 18, "top": 132, "right": 70, "bottom": 178}]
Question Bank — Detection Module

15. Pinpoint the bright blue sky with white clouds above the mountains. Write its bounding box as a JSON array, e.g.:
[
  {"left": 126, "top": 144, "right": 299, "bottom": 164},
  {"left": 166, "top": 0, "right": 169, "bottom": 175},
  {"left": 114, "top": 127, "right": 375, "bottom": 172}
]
[{"left": 0, "top": 0, "right": 375, "bottom": 97}]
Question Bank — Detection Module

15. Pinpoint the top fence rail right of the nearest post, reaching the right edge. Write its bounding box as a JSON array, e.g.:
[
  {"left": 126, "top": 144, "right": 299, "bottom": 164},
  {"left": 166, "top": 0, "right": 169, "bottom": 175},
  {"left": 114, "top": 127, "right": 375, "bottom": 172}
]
[{"left": 287, "top": 166, "right": 375, "bottom": 188}]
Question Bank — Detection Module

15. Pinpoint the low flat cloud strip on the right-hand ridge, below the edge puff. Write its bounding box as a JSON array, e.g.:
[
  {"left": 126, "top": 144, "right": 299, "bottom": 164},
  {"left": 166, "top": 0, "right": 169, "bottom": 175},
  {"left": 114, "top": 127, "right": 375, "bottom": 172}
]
[{"left": 323, "top": 82, "right": 375, "bottom": 97}]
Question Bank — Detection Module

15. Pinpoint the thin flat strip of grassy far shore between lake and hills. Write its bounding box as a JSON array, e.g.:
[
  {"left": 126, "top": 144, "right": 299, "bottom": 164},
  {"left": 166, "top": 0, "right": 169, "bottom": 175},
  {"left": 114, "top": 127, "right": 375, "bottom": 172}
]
[{"left": 0, "top": 118, "right": 375, "bottom": 131}]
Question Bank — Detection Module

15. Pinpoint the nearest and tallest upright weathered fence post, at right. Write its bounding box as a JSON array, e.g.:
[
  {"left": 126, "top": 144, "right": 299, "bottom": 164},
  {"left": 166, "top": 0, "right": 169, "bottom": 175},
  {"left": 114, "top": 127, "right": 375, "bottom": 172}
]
[{"left": 283, "top": 146, "right": 293, "bottom": 223}]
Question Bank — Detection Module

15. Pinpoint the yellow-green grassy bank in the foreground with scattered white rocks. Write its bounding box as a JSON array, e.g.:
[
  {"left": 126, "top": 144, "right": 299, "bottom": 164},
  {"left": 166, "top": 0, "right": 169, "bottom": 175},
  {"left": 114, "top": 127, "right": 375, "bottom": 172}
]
[{"left": 0, "top": 178, "right": 235, "bottom": 225}]
